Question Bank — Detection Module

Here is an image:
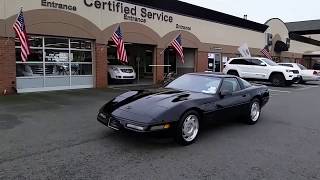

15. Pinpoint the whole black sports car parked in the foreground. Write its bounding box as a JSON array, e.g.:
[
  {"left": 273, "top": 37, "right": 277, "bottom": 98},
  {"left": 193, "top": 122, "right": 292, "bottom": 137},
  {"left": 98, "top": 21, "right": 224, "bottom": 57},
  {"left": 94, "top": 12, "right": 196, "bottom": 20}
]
[{"left": 98, "top": 73, "right": 269, "bottom": 145}]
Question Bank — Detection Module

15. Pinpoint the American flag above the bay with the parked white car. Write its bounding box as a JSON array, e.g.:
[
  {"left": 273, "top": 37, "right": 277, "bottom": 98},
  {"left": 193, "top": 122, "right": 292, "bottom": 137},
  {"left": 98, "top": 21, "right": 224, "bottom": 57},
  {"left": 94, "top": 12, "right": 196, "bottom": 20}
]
[{"left": 112, "top": 26, "right": 128, "bottom": 63}]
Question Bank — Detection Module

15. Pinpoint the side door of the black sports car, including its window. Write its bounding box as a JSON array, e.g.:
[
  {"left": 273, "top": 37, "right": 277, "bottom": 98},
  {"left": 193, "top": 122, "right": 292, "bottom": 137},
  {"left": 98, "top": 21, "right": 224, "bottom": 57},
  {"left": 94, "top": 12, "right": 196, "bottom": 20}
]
[{"left": 215, "top": 78, "right": 250, "bottom": 119}]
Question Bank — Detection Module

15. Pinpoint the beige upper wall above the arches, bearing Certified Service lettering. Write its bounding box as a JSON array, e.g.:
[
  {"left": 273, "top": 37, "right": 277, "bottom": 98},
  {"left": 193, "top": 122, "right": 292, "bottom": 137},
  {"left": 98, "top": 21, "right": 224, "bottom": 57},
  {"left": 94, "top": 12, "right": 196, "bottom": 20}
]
[{"left": 0, "top": 0, "right": 265, "bottom": 48}]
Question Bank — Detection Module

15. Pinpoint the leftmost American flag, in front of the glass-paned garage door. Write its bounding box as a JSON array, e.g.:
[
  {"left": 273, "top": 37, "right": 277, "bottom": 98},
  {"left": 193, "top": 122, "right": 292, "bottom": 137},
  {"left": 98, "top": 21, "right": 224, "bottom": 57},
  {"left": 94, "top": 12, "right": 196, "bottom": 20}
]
[{"left": 13, "top": 10, "right": 30, "bottom": 62}]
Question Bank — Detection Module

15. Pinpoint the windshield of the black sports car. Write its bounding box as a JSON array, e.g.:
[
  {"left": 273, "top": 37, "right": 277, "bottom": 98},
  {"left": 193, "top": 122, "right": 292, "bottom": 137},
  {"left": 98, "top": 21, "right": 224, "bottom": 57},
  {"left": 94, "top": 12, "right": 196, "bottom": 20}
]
[{"left": 166, "top": 74, "right": 221, "bottom": 94}]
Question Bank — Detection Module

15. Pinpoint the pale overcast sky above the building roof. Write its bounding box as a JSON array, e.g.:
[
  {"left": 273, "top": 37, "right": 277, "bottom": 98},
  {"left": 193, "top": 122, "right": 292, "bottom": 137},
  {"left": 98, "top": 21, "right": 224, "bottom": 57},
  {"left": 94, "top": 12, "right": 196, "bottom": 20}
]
[{"left": 181, "top": 0, "right": 320, "bottom": 23}]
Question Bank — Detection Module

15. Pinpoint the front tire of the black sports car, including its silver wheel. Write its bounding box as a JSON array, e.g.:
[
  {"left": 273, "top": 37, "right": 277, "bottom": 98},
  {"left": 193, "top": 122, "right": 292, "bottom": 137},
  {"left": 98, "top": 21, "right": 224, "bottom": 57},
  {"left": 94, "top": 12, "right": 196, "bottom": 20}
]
[{"left": 175, "top": 110, "right": 200, "bottom": 146}]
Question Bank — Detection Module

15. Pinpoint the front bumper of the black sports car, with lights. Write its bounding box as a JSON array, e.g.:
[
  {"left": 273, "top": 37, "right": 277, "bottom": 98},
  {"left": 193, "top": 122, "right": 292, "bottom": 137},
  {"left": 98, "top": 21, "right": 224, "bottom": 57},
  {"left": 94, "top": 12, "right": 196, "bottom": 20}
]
[{"left": 97, "top": 112, "right": 175, "bottom": 133}]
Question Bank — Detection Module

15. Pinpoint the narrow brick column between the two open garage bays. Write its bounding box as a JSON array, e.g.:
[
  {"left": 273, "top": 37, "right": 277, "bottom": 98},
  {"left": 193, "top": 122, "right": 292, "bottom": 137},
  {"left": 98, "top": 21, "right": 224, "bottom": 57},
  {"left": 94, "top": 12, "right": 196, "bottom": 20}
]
[{"left": 153, "top": 48, "right": 164, "bottom": 84}]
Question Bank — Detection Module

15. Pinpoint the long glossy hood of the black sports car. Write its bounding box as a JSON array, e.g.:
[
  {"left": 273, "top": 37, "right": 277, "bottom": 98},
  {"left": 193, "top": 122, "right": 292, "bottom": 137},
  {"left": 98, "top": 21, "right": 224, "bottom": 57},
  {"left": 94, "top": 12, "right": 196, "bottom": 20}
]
[{"left": 103, "top": 89, "right": 210, "bottom": 122}]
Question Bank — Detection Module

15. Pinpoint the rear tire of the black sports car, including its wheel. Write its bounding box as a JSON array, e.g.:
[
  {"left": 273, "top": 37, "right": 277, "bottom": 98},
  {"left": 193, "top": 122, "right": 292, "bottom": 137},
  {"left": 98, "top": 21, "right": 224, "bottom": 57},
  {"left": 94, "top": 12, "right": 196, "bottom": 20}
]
[{"left": 246, "top": 98, "right": 261, "bottom": 125}]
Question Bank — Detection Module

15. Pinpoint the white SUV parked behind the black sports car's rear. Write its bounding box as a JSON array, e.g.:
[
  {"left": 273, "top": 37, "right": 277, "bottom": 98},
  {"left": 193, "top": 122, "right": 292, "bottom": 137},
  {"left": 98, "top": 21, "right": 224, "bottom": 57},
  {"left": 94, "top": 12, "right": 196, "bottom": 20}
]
[{"left": 223, "top": 57, "right": 300, "bottom": 86}]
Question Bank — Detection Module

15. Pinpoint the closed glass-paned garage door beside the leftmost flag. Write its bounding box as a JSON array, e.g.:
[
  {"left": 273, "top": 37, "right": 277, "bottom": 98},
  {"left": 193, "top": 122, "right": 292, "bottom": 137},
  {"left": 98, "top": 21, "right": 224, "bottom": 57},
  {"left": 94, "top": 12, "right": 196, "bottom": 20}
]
[{"left": 16, "top": 36, "right": 94, "bottom": 90}]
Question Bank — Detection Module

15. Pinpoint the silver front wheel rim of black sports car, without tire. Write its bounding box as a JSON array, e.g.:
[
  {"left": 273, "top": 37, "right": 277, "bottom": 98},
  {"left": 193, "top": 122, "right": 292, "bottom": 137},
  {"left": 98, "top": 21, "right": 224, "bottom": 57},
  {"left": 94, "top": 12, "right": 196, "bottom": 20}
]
[{"left": 182, "top": 115, "right": 199, "bottom": 142}]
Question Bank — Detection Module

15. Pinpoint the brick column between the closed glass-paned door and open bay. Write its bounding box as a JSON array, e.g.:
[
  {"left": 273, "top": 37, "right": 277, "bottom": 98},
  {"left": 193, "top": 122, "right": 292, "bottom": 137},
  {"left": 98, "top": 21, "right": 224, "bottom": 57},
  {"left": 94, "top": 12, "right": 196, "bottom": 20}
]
[{"left": 95, "top": 44, "right": 108, "bottom": 88}]
